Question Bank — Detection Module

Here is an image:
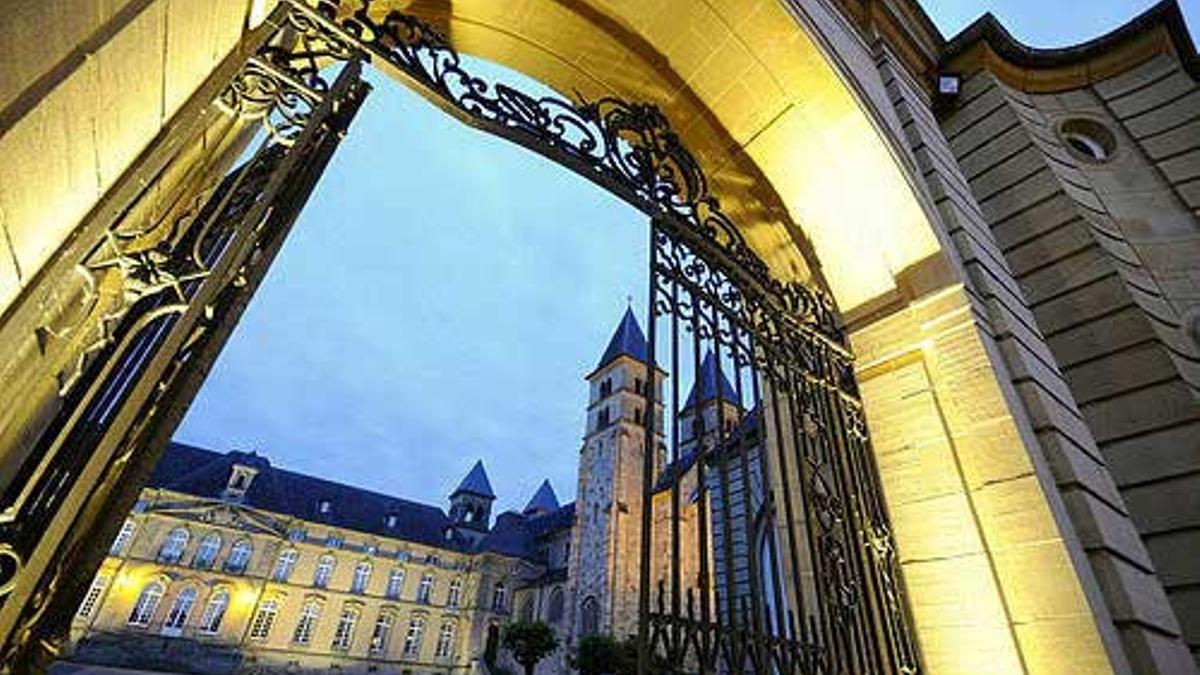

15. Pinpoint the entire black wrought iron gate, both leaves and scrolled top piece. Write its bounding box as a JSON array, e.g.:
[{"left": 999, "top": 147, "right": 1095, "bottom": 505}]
[{"left": 0, "top": 0, "right": 918, "bottom": 674}]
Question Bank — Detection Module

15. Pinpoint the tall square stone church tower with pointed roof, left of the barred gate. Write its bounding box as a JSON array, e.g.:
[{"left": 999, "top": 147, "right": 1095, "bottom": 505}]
[{"left": 570, "top": 310, "right": 667, "bottom": 640}]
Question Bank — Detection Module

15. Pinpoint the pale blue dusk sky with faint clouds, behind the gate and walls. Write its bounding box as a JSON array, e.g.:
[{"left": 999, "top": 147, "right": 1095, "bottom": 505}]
[{"left": 176, "top": 0, "right": 1200, "bottom": 513}]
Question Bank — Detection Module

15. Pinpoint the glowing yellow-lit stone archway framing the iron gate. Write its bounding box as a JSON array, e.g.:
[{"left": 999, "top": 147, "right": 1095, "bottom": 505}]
[{"left": 0, "top": 0, "right": 1132, "bottom": 671}]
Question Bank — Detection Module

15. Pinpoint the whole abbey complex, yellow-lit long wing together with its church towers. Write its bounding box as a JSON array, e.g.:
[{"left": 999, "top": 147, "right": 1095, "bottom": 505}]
[{"left": 63, "top": 311, "right": 742, "bottom": 675}]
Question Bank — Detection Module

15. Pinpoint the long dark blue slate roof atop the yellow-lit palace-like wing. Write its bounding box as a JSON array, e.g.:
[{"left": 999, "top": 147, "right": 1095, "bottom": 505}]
[{"left": 150, "top": 443, "right": 453, "bottom": 548}]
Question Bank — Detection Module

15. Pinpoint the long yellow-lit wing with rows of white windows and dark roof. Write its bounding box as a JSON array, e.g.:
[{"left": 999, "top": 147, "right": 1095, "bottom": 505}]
[{"left": 60, "top": 444, "right": 539, "bottom": 674}]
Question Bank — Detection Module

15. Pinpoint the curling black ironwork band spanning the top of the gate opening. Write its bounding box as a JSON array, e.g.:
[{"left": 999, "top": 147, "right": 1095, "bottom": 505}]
[{"left": 292, "top": 0, "right": 846, "bottom": 346}]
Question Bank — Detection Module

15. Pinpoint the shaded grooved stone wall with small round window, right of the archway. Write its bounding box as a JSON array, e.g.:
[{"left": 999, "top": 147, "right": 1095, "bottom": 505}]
[{"left": 942, "top": 57, "right": 1200, "bottom": 671}]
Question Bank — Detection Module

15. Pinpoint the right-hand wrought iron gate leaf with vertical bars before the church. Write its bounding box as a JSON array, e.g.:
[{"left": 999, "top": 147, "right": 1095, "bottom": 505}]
[{"left": 638, "top": 217, "right": 919, "bottom": 675}]
